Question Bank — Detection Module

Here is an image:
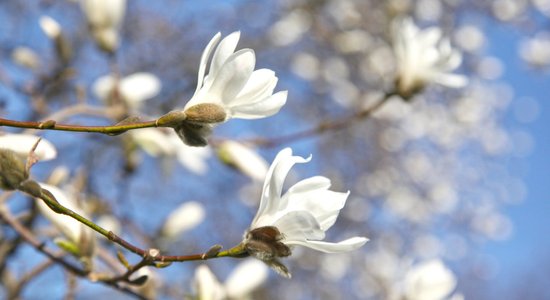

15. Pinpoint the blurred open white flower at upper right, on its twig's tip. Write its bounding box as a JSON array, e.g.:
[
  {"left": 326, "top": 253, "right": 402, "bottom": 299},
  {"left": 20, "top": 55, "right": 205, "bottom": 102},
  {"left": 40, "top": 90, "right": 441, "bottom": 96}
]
[{"left": 392, "top": 18, "right": 467, "bottom": 99}]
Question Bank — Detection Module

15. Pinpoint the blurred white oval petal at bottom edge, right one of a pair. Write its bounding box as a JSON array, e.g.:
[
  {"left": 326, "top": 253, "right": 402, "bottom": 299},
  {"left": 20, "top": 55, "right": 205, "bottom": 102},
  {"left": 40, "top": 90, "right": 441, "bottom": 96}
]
[{"left": 225, "top": 259, "right": 269, "bottom": 299}]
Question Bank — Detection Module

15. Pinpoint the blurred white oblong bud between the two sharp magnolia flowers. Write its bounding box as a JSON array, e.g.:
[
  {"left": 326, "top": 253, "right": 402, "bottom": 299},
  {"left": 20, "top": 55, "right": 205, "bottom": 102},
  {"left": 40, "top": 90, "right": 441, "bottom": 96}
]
[{"left": 218, "top": 141, "right": 268, "bottom": 181}]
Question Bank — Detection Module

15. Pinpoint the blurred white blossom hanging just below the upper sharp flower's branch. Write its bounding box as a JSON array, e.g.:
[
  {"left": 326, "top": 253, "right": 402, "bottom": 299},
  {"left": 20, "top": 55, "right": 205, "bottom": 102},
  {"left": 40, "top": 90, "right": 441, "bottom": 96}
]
[{"left": 129, "top": 128, "right": 212, "bottom": 175}]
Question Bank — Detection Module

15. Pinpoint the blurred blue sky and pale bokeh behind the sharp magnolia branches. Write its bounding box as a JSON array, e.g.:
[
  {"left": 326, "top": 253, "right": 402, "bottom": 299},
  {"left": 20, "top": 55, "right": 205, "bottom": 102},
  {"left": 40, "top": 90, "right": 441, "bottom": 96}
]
[{"left": 0, "top": 0, "right": 550, "bottom": 299}]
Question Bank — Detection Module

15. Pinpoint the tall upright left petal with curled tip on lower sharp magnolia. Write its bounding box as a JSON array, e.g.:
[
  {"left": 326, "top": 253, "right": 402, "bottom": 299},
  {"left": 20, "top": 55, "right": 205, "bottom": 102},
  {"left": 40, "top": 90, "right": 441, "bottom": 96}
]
[{"left": 252, "top": 148, "right": 311, "bottom": 228}]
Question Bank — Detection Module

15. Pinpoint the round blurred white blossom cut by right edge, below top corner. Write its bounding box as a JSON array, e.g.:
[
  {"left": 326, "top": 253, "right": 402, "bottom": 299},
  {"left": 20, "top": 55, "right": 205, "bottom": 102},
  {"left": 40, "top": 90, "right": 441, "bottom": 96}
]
[{"left": 519, "top": 32, "right": 550, "bottom": 67}]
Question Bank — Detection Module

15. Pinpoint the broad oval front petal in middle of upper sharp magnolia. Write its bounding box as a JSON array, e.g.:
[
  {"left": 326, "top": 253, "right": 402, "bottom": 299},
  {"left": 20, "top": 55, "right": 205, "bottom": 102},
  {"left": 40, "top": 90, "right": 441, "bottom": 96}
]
[{"left": 206, "top": 49, "right": 256, "bottom": 104}]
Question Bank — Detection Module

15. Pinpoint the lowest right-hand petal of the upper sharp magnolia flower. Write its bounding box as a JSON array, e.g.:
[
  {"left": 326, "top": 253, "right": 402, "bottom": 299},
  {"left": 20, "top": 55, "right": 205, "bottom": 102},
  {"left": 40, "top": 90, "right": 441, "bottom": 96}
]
[{"left": 230, "top": 91, "right": 288, "bottom": 119}]
